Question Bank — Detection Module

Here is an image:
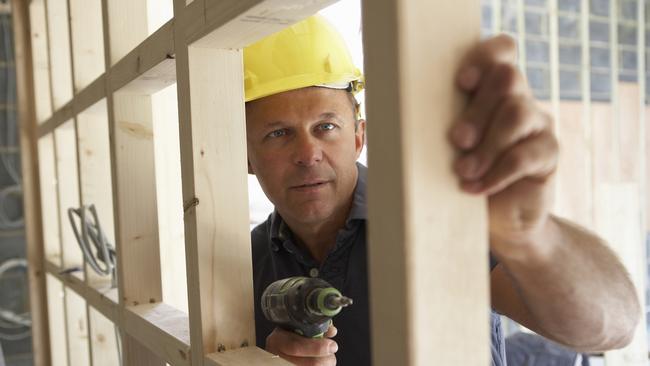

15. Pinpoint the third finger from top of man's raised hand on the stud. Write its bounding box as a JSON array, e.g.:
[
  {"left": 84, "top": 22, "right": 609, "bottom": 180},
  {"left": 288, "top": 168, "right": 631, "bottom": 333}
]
[{"left": 454, "top": 97, "right": 551, "bottom": 180}]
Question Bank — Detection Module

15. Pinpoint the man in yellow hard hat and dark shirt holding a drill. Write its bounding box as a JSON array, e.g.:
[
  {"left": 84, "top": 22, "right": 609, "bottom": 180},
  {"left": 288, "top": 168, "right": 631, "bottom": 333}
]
[{"left": 244, "top": 16, "right": 640, "bottom": 366}]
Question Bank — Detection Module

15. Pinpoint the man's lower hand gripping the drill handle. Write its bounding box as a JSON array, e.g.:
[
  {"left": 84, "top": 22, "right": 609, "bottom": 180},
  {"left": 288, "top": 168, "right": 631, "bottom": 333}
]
[{"left": 265, "top": 325, "right": 339, "bottom": 366}]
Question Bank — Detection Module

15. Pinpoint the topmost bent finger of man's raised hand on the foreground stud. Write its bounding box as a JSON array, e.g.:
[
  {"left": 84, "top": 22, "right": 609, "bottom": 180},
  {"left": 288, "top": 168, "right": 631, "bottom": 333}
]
[{"left": 457, "top": 34, "right": 517, "bottom": 92}]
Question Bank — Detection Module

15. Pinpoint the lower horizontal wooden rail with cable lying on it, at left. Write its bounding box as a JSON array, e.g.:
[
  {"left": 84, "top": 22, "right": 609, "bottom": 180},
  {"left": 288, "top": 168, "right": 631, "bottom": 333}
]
[{"left": 45, "top": 261, "right": 191, "bottom": 366}]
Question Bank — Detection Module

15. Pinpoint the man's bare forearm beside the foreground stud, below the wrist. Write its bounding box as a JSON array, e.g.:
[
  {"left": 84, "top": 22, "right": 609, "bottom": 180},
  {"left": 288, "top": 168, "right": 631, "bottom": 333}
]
[{"left": 495, "top": 217, "right": 640, "bottom": 350}]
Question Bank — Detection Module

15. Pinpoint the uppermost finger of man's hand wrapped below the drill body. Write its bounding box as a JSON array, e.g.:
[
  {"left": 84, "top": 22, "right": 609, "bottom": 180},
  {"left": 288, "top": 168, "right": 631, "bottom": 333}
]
[{"left": 266, "top": 328, "right": 338, "bottom": 357}]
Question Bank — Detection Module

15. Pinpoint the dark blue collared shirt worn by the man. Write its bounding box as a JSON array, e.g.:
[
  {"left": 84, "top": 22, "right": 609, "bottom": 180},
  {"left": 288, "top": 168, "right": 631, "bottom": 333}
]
[{"left": 251, "top": 164, "right": 505, "bottom": 366}]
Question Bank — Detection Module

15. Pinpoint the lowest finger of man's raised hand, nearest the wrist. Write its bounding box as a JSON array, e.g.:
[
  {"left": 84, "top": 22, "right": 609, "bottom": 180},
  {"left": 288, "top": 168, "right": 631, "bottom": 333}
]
[{"left": 461, "top": 131, "right": 558, "bottom": 195}]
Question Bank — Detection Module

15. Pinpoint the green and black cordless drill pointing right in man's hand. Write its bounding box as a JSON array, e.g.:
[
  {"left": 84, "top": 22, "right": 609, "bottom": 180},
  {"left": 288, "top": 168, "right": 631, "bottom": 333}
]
[{"left": 262, "top": 277, "right": 352, "bottom": 338}]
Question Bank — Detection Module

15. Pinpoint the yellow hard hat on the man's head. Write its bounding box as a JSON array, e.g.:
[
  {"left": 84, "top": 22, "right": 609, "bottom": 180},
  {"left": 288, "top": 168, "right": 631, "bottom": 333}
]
[{"left": 244, "top": 15, "right": 364, "bottom": 102}]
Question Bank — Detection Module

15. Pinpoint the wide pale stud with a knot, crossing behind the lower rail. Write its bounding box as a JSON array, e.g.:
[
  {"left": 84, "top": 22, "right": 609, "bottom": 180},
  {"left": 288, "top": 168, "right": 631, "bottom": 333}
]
[{"left": 109, "top": 92, "right": 162, "bottom": 365}]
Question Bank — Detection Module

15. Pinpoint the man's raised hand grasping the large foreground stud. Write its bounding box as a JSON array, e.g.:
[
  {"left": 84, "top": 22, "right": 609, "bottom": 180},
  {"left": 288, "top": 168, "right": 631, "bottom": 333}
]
[{"left": 450, "top": 36, "right": 558, "bottom": 257}]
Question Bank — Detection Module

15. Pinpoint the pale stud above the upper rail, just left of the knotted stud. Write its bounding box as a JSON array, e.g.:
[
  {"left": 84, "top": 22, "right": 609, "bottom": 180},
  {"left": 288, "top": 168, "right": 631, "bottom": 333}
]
[{"left": 69, "top": 0, "right": 105, "bottom": 92}]
